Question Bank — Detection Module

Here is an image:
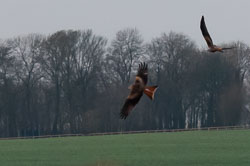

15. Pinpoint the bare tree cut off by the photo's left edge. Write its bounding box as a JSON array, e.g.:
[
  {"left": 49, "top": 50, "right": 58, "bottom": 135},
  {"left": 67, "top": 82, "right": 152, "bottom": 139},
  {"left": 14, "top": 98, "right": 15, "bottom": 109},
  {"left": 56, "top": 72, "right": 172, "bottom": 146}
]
[{"left": 0, "top": 43, "right": 18, "bottom": 137}]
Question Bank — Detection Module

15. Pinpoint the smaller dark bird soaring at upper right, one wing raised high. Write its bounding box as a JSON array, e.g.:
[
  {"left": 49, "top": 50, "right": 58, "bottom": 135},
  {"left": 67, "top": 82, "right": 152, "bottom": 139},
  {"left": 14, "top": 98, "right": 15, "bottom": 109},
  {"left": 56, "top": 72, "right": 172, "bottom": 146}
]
[{"left": 200, "top": 16, "right": 234, "bottom": 52}]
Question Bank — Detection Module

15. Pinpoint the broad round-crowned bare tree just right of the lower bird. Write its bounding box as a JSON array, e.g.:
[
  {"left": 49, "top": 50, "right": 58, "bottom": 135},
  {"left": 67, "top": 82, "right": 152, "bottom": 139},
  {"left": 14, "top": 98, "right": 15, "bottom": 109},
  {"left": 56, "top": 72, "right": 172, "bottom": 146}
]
[{"left": 147, "top": 32, "right": 196, "bottom": 128}]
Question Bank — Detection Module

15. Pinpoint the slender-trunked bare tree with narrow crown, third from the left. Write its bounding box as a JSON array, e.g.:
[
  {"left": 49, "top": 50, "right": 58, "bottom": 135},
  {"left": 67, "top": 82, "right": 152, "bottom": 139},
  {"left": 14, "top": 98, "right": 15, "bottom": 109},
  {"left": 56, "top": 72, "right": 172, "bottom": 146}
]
[{"left": 40, "top": 31, "right": 67, "bottom": 134}]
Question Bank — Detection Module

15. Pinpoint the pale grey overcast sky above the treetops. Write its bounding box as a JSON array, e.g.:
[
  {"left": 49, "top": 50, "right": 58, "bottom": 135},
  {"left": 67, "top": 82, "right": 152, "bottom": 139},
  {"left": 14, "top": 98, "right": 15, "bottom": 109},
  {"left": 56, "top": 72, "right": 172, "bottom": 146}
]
[{"left": 0, "top": 0, "right": 250, "bottom": 47}]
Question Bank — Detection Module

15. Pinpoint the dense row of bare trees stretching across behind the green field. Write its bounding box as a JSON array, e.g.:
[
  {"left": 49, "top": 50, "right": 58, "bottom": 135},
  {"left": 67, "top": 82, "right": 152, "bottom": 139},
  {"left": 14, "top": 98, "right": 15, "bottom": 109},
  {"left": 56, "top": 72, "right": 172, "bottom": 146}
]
[{"left": 0, "top": 28, "right": 250, "bottom": 137}]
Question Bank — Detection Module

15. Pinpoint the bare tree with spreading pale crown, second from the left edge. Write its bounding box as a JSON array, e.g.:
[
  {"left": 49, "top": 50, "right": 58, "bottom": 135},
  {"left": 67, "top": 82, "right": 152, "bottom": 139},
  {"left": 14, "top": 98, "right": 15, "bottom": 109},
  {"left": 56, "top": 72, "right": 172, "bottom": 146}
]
[{"left": 8, "top": 34, "right": 43, "bottom": 135}]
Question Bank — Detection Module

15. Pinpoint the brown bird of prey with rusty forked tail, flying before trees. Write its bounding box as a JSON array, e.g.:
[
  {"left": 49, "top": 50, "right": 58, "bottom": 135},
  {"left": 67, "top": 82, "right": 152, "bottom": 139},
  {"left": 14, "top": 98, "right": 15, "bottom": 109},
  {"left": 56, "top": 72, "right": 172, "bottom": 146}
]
[{"left": 120, "top": 63, "right": 158, "bottom": 119}]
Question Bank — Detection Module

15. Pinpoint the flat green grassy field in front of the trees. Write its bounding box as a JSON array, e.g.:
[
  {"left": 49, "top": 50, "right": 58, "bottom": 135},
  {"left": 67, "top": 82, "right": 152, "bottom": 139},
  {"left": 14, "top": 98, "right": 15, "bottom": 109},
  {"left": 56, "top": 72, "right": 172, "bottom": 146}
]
[{"left": 0, "top": 130, "right": 250, "bottom": 166}]
